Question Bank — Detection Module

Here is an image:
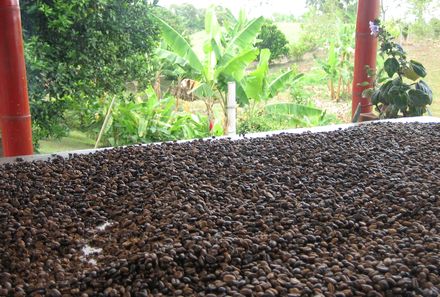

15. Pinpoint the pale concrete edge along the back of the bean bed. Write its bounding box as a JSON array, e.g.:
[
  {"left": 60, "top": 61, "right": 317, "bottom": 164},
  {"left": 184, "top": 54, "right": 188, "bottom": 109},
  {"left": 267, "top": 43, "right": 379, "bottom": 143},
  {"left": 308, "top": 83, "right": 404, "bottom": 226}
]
[{"left": 0, "top": 116, "right": 440, "bottom": 165}]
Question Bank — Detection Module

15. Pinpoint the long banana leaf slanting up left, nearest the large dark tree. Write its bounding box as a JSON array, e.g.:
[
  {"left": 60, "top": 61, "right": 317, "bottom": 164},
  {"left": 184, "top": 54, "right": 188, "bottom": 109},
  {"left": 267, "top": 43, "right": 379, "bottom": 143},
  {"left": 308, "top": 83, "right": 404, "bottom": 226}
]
[{"left": 151, "top": 14, "right": 203, "bottom": 73}]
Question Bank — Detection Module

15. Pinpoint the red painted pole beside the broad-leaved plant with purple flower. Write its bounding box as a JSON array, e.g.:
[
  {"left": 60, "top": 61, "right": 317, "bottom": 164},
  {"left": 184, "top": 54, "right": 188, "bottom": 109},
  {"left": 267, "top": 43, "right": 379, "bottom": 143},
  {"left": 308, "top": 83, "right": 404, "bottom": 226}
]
[{"left": 352, "top": 0, "right": 380, "bottom": 116}]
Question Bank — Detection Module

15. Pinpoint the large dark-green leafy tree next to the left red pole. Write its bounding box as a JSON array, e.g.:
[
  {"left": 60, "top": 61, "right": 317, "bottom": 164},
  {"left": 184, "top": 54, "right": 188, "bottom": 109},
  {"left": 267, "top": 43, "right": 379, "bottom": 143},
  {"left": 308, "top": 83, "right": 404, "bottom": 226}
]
[{"left": 21, "top": 0, "right": 159, "bottom": 142}]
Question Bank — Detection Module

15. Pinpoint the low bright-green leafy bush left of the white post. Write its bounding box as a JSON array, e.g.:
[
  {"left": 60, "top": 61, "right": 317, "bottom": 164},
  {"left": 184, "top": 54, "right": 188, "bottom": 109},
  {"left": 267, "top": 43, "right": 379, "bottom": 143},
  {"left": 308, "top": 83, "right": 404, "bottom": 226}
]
[{"left": 95, "top": 87, "right": 222, "bottom": 146}]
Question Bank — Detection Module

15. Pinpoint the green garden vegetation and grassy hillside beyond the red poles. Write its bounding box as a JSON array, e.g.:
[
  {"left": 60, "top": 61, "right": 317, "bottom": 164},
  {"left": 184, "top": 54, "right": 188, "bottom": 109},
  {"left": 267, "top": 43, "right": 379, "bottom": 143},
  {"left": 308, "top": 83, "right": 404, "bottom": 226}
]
[{"left": 21, "top": 0, "right": 440, "bottom": 152}]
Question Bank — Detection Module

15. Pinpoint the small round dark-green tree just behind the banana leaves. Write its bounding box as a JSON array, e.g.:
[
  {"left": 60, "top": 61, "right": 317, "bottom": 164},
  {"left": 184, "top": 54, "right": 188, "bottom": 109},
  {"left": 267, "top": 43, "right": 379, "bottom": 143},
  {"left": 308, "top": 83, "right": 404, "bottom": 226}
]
[{"left": 255, "top": 22, "right": 289, "bottom": 61}]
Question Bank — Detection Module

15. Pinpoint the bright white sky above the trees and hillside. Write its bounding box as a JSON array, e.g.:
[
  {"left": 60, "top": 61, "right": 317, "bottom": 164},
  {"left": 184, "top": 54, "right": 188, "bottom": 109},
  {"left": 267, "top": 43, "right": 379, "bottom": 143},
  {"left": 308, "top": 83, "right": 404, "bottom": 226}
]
[{"left": 159, "top": 0, "right": 440, "bottom": 20}]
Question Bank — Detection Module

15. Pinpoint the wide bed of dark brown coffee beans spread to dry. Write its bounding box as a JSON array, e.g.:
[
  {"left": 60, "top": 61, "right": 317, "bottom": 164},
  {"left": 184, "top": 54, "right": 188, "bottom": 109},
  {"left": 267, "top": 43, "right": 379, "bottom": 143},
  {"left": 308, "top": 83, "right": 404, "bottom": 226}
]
[{"left": 0, "top": 123, "right": 440, "bottom": 297}]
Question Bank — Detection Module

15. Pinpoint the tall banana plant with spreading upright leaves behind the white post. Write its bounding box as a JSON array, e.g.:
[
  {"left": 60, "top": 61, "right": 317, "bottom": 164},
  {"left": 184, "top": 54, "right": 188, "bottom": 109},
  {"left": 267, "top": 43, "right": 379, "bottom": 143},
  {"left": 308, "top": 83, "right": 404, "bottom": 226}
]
[{"left": 153, "top": 10, "right": 264, "bottom": 130}]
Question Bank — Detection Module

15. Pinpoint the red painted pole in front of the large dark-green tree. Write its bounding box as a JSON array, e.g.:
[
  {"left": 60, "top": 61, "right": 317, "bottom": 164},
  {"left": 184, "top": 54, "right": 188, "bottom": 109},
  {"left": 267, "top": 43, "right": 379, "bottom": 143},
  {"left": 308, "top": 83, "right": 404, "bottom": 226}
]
[{"left": 0, "top": 0, "right": 33, "bottom": 157}]
